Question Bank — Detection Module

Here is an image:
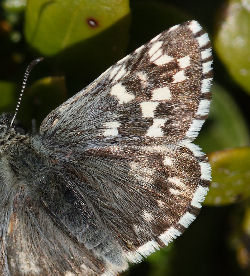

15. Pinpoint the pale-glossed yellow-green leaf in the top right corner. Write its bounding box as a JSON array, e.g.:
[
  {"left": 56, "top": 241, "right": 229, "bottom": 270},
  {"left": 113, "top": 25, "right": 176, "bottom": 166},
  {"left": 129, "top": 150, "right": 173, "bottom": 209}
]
[{"left": 214, "top": 0, "right": 250, "bottom": 93}]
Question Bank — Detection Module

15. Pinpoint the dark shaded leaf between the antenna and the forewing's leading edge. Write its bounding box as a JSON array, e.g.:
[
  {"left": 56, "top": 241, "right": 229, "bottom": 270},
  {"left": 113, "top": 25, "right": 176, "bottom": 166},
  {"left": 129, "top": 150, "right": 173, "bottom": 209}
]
[{"left": 19, "top": 77, "right": 66, "bottom": 128}]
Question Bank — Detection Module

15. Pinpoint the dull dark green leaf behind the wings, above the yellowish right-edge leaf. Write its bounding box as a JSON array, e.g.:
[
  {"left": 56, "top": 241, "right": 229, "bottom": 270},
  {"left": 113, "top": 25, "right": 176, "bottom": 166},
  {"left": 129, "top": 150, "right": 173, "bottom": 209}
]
[{"left": 196, "top": 84, "right": 249, "bottom": 152}]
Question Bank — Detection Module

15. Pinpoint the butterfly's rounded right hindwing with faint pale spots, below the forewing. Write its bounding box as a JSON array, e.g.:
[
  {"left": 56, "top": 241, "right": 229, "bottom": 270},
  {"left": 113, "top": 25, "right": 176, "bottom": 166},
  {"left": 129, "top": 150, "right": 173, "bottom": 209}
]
[{"left": 79, "top": 142, "right": 210, "bottom": 262}]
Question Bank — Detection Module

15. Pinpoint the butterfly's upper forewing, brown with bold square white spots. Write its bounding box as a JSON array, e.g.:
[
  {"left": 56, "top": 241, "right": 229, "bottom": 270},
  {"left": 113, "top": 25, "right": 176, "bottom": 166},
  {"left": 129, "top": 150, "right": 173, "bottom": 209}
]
[{"left": 41, "top": 21, "right": 212, "bottom": 147}]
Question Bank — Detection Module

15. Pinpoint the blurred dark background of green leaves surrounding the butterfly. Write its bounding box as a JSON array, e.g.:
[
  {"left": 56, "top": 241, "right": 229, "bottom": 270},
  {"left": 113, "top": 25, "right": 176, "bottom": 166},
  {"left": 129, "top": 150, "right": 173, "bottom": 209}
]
[{"left": 0, "top": 0, "right": 250, "bottom": 276}]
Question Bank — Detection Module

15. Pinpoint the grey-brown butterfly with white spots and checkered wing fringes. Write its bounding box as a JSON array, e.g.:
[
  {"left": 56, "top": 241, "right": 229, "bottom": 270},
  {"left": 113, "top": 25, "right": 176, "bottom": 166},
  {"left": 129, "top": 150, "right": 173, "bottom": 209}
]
[{"left": 0, "top": 21, "right": 212, "bottom": 276}]
